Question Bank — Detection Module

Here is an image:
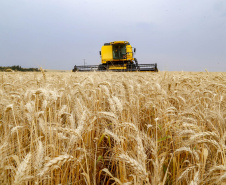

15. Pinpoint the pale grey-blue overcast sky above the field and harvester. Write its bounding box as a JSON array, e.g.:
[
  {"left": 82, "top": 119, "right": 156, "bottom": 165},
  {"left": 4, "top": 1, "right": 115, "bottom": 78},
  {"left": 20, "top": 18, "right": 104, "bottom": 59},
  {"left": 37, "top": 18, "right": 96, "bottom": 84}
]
[{"left": 0, "top": 0, "right": 226, "bottom": 72}]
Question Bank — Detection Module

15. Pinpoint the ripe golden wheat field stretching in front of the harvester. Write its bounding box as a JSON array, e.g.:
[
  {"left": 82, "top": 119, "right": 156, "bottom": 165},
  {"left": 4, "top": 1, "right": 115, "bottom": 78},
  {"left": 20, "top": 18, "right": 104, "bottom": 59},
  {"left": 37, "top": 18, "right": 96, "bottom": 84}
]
[{"left": 0, "top": 71, "right": 226, "bottom": 185}]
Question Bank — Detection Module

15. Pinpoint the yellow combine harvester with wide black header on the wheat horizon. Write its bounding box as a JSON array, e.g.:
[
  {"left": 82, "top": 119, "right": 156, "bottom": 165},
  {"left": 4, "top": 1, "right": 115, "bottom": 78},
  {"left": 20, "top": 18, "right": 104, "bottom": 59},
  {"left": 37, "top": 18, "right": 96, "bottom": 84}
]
[{"left": 72, "top": 41, "right": 158, "bottom": 72}]
